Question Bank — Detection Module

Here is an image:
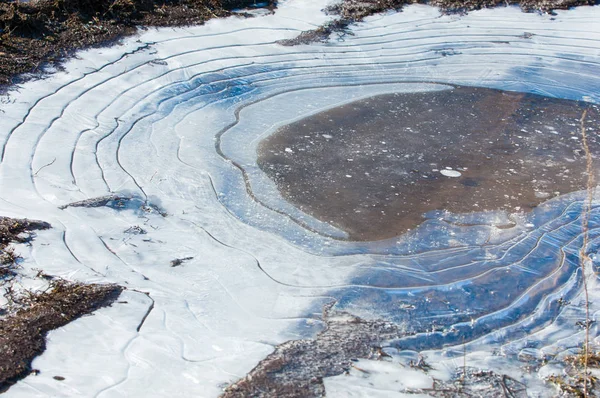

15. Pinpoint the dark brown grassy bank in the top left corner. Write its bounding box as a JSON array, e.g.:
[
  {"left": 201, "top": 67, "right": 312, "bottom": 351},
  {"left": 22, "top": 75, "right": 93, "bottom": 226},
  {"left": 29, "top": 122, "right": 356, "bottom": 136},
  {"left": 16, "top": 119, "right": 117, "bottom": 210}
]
[{"left": 0, "top": 0, "right": 273, "bottom": 92}]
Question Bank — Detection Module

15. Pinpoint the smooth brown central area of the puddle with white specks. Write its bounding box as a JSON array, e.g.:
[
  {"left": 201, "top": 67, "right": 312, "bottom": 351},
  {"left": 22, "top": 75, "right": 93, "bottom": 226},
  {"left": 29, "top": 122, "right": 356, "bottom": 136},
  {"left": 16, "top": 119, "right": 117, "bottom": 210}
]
[{"left": 258, "top": 87, "right": 600, "bottom": 241}]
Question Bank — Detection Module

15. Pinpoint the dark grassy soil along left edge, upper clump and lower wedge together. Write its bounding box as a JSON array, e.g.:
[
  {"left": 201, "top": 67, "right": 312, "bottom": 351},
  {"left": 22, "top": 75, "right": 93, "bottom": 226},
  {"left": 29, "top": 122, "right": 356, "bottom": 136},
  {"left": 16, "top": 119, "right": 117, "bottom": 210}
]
[{"left": 0, "top": 217, "right": 122, "bottom": 393}]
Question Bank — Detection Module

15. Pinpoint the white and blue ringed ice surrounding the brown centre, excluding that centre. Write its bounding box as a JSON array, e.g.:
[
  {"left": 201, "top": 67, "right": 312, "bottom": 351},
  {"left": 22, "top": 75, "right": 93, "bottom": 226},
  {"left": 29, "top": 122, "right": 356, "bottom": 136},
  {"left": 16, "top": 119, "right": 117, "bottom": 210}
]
[{"left": 0, "top": 0, "right": 600, "bottom": 397}]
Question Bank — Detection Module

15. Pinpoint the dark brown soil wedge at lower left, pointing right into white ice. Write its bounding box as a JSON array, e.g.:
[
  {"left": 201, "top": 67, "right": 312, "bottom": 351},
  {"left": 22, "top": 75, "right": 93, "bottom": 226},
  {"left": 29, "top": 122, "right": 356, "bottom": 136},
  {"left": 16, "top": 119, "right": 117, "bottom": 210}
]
[{"left": 0, "top": 279, "right": 123, "bottom": 392}]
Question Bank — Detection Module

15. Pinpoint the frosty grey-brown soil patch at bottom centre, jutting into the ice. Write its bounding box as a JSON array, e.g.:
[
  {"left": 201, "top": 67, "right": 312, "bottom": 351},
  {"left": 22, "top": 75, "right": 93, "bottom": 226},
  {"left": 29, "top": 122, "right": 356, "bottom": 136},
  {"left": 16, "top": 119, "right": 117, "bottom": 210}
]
[{"left": 221, "top": 309, "right": 400, "bottom": 398}]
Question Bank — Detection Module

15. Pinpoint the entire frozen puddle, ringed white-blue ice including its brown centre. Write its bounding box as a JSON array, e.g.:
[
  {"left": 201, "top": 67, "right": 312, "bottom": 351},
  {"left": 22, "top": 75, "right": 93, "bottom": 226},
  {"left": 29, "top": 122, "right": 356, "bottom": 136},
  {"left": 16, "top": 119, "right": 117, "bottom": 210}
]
[{"left": 0, "top": 0, "right": 600, "bottom": 397}]
